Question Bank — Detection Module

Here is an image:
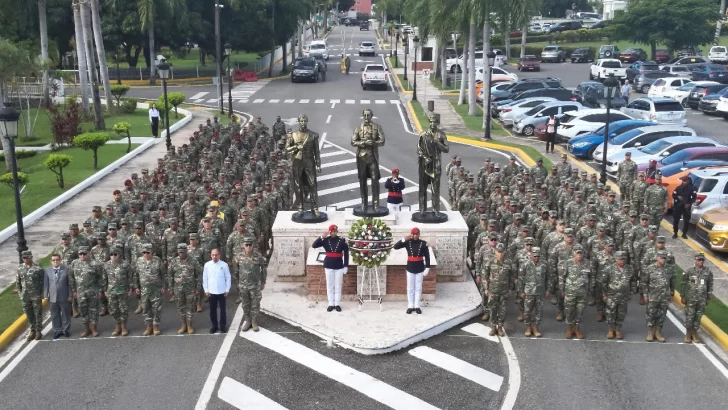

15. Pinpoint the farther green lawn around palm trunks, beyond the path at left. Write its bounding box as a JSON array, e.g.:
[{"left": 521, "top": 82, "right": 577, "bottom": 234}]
[{"left": 16, "top": 108, "right": 183, "bottom": 147}]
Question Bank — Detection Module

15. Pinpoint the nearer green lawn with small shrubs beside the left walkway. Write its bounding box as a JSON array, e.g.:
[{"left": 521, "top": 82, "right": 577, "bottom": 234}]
[{"left": 0, "top": 144, "right": 139, "bottom": 229}]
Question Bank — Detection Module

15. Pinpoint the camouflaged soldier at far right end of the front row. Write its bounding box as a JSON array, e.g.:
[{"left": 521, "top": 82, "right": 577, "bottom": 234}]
[{"left": 680, "top": 253, "right": 713, "bottom": 343}]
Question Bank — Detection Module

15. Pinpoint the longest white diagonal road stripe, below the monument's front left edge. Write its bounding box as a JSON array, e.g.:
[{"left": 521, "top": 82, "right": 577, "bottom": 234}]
[{"left": 240, "top": 326, "right": 437, "bottom": 410}]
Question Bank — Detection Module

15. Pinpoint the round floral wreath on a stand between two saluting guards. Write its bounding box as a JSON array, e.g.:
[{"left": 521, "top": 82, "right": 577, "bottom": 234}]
[{"left": 349, "top": 218, "right": 392, "bottom": 268}]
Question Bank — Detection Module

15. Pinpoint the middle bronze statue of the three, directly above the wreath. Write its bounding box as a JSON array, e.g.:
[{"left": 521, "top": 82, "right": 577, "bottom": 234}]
[{"left": 351, "top": 108, "right": 386, "bottom": 215}]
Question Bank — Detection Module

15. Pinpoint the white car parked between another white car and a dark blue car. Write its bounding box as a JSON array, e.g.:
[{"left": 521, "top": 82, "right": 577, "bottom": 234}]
[{"left": 607, "top": 135, "right": 722, "bottom": 174}]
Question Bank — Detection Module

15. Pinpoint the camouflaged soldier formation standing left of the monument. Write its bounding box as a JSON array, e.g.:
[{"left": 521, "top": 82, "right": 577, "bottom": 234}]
[{"left": 17, "top": 117, "right": 293, "bottom": 340}]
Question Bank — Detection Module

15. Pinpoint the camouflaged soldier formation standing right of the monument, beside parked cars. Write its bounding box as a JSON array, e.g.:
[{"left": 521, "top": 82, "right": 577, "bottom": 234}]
[{"left": 458, "top": 154, "right": 713, "bottom": 343}]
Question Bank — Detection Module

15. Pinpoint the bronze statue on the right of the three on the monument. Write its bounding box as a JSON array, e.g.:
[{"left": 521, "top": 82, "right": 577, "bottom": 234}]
[{"left": 417, "top": 114, "right": 450, "bottom": 214}]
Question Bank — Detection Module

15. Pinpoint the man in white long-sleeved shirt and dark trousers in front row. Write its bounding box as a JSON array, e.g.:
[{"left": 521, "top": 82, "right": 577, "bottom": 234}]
[{"left": 202, "top": 249, "right": 230, "bottom": 333}]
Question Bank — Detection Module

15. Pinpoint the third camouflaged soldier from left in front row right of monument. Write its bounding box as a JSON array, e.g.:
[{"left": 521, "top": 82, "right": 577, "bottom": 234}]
[{"left": 559, "top": 245, "right": 592, "bottom": 339}]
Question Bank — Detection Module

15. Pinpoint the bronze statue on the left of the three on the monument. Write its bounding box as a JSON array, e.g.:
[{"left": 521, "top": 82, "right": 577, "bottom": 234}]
[{"left": 286, "top": 115, "right": 321, "bottom": 217}]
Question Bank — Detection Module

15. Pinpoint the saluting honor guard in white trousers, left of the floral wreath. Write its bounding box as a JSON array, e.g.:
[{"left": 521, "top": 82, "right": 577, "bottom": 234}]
[{"left": 312, "top": 225, "right": 349, "bottom": 312}]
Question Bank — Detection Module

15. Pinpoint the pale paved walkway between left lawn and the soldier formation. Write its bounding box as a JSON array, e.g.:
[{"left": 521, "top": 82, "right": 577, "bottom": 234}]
[{"left": 0, "top": 108, "right": 212, "bottom": 289}]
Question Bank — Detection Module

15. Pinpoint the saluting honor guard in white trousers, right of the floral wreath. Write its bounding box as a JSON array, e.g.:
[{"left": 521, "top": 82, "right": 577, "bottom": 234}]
[{"left": 394, "top": 227, "right": 430, "bottom": 315}]
